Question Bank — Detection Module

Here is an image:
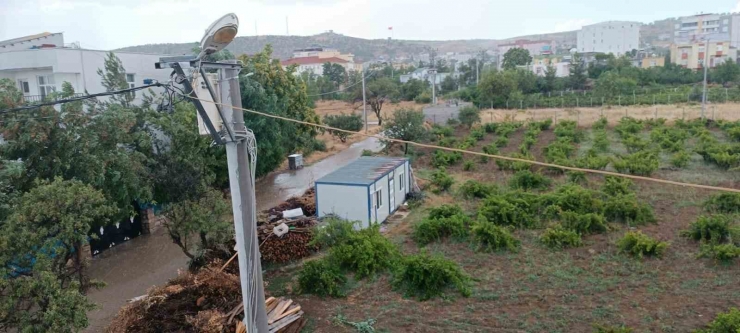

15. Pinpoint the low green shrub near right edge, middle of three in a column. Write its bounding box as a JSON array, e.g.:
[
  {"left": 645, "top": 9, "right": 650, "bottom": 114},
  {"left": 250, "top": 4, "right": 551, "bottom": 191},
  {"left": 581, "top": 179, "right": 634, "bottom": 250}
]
[{"left": 681, "top": 215, "right": 740, "bottom": 244}]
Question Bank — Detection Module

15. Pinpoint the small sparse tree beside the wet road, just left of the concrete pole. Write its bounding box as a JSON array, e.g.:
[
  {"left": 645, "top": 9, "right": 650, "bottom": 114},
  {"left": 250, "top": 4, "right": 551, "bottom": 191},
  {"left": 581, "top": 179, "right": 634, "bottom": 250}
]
[{"left": 164, "top": 190, "right": 234, "bottom": 265}]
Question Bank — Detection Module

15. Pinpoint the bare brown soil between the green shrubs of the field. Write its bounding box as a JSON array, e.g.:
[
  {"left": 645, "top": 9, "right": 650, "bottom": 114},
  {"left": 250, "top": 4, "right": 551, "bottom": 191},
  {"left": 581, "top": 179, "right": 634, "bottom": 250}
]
[{"left": 265, "top": 120, "right": 740, "bottom": 332}]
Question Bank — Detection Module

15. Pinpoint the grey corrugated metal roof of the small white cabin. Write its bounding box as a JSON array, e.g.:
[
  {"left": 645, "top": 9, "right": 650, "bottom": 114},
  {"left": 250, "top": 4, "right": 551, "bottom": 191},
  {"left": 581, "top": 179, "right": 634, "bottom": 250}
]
[{"left": 316, "top": 156, "right": 408, "bottom": 185}]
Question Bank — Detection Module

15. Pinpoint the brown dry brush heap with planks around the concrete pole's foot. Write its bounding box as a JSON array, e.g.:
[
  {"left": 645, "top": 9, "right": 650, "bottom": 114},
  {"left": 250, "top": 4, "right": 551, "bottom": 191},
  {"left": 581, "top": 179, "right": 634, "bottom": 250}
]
[{"left": 106, "top": 260, "right": 306, "bottom": 333}]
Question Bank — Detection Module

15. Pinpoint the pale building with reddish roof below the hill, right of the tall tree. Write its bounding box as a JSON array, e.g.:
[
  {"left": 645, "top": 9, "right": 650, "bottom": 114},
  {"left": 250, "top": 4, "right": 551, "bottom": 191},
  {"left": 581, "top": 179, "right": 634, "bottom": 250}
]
[{"left": 280, "top": 47, "right": 362, "bottom": 75}]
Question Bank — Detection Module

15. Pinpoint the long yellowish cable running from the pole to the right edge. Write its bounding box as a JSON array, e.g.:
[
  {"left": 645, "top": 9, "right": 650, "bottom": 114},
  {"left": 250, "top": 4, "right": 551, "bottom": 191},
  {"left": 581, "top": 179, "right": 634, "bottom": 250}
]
[{"left": 181, "top": 92, "right": 740, "bottom": 193}]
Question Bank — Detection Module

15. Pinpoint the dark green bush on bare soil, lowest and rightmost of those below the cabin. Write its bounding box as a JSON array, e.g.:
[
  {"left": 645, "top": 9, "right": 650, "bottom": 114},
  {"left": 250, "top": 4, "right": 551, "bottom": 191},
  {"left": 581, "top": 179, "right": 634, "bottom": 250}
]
[{"left": 393, "top": 251, "right": 472, "bottom": 300}]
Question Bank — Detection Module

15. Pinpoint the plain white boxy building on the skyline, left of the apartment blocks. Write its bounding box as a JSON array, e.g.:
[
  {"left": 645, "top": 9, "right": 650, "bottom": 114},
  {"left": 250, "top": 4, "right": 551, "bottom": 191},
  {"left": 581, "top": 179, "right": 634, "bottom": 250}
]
[{"left": 577, "top": 21, "right": 642, "bottom": 56}]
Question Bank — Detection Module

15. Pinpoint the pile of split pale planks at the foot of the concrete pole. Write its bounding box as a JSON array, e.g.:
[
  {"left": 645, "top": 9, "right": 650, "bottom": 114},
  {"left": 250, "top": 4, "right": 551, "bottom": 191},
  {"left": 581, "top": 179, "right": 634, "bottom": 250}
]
[{"left": 227, "top": 297, "right": 306, "bottom": 333}]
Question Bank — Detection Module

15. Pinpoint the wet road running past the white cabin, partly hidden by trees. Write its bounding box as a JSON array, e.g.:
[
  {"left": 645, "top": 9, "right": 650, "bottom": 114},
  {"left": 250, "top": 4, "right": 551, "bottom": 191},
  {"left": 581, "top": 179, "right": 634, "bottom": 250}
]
[{"left": 85, "top": 138, "right": 381, "bottom": 332}]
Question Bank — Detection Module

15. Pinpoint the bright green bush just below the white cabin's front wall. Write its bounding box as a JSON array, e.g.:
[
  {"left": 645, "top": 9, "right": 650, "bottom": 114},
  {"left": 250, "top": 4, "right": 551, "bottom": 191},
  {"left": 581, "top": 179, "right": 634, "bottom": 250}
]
[{"left": 329, "top": 224, "right": 400, "bottom": 278}]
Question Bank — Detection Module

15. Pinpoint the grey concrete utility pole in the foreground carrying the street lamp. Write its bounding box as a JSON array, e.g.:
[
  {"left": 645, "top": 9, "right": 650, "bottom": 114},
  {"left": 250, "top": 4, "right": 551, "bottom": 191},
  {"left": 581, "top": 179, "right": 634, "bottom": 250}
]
[{"left": 219, "top": 60, "right": 268, "bottom": 332}]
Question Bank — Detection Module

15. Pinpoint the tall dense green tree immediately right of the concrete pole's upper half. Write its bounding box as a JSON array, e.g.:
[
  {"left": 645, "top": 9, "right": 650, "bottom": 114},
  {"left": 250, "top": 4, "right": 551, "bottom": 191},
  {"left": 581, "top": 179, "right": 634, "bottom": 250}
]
[{"left": 239, "top": 45, "right": 319, "bottom": 177}]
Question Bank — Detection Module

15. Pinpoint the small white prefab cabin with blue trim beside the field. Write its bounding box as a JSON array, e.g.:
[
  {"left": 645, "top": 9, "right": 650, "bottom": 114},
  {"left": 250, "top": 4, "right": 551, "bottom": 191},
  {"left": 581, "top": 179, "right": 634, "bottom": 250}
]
[{"left": 315, "top": 157, "right": 411, "bottom": 228}]
